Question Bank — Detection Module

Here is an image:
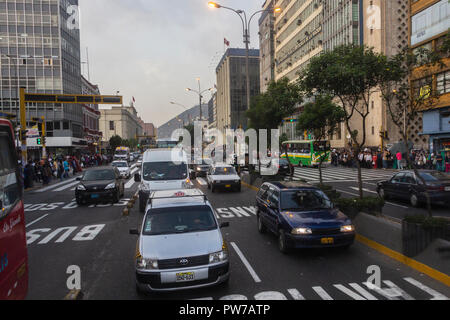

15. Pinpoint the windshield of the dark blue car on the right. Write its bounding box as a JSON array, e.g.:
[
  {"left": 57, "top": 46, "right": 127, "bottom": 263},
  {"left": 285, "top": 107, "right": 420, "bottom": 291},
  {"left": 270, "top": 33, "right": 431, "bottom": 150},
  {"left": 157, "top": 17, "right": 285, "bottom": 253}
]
[{"left": 281, "top": 190, "right": 332, "bottom": 211}]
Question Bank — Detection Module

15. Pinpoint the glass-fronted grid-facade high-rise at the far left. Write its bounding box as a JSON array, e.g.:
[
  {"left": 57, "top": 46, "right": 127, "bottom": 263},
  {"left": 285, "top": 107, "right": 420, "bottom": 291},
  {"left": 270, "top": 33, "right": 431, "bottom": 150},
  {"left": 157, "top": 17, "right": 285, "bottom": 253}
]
[{"left": 0, "top": 0, "right": 83, "bottom": 153}]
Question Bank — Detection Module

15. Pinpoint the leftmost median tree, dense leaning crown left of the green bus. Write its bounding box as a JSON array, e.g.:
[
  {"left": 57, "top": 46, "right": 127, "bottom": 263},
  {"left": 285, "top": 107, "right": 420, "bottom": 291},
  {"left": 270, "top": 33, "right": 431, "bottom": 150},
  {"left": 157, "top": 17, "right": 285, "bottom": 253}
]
[{"left": 246, "top": 78, "right": 303, "bottom": 177}]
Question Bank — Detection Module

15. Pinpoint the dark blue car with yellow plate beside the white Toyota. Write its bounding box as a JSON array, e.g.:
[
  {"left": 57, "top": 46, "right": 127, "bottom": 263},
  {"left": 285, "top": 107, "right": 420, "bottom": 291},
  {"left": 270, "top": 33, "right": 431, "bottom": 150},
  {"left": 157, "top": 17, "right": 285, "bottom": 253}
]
[{"left": 256, "top": 182, "right": 355, "bottom": 253}]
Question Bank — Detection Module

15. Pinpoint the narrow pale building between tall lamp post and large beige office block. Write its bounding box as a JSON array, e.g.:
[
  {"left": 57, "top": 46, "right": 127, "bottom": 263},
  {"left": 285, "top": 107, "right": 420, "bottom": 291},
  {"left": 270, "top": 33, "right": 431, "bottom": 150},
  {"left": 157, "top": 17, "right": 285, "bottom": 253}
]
[{"left": 258, "top": 0, "right": 275, "bottom": 92}]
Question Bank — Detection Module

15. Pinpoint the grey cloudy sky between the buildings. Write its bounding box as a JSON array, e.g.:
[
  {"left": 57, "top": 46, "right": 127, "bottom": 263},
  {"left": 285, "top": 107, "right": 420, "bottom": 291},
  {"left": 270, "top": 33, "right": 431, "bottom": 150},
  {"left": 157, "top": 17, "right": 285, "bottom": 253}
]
[{"left": 79, "top": 0, "right": 264, "bottom": 126}]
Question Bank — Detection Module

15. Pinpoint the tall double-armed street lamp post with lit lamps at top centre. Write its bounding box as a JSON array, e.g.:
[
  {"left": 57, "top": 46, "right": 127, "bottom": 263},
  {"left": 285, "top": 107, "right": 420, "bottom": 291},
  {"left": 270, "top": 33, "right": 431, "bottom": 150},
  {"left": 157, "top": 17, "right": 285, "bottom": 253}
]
[{"left": 208, "top": 1, "right": 281, "bottom": 127}]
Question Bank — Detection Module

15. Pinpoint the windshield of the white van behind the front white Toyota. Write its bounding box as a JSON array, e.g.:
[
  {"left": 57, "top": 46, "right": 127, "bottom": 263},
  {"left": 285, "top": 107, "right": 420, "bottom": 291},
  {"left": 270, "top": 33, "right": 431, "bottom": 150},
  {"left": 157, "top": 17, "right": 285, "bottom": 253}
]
[{"left": 143, "top": 161, "right": 188, "bottom": 181}]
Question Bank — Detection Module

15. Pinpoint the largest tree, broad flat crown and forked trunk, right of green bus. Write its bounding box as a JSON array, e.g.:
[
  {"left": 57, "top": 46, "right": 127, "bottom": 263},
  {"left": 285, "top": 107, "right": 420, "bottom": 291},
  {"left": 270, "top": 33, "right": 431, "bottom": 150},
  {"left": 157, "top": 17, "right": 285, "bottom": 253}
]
[{"left": 299, "top": 44, "right": 386, "bottom": 198}]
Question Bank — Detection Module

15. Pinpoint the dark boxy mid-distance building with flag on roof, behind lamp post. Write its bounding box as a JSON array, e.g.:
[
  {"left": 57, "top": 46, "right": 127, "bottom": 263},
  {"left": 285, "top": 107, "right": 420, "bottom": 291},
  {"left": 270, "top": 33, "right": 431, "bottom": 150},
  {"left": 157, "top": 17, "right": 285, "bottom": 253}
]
[{"left": 216, "top": 48, "right": 260, "bottom": 131}]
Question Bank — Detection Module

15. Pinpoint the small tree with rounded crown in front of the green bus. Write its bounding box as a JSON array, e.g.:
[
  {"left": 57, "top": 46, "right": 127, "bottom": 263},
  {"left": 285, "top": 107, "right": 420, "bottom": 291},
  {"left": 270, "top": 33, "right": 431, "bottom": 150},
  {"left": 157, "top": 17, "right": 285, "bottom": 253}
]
[{"left": 297, "top": 95, "right": 345, "bottom": 185}]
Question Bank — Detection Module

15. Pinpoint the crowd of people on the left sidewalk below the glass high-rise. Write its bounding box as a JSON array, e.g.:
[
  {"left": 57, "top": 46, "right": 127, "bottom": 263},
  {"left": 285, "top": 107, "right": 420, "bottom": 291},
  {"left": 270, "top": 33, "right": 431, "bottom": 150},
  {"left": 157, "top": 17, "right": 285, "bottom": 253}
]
[{"left": 22, "top": 154, "right": 110, "bottom": 189}]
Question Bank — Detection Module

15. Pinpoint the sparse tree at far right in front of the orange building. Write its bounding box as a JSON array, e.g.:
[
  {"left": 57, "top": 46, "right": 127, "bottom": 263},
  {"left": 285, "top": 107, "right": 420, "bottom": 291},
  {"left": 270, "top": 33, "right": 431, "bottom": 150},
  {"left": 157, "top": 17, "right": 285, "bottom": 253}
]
[{"left": 380, "top": 32, "right": 450, "bottom": 217}]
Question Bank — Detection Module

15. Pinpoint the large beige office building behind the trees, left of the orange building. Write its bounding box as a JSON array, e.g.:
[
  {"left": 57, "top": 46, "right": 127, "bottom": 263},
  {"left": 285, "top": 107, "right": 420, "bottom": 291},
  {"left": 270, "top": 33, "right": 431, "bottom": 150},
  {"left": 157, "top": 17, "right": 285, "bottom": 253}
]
[{"left": 275, "top": 0, "right": 418, "bottom": 148}]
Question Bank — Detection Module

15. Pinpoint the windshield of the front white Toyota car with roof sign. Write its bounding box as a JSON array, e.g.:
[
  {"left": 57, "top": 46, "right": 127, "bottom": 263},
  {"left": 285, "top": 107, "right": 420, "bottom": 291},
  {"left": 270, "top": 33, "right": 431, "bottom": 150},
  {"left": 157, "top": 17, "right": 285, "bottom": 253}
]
[{"left": 143, "top": 206, "right": 217, "bottom": 236}]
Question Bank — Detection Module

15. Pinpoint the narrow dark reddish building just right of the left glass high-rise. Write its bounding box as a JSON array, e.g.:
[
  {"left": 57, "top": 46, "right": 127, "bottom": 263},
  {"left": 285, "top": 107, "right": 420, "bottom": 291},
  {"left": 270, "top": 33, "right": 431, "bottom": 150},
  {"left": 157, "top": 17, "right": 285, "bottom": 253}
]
[{"left": 81, "top": 76, "right": 102, "bottom": 152}]
